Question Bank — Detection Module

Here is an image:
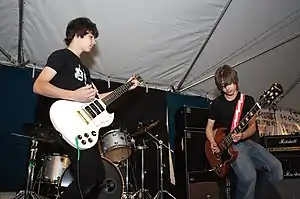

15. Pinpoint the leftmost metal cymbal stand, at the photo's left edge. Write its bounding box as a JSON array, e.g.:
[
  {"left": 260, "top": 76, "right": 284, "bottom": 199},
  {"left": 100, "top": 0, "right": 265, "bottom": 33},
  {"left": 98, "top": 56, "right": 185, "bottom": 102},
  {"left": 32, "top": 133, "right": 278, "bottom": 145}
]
[{"left": 11, "top": 134, "right": 40, "bottom": 199}]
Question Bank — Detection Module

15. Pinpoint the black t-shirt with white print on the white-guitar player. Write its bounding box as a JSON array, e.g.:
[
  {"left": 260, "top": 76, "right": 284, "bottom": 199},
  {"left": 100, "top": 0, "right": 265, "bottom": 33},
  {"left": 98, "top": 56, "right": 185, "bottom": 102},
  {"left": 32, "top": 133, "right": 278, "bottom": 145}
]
[{"left": 35, "top": 49, "right": 91, "bottom": 126}]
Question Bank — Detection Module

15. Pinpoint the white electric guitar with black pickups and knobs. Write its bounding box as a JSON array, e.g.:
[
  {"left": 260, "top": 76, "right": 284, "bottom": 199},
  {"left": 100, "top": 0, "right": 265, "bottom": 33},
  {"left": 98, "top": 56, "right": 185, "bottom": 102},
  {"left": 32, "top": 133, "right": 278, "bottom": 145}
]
[{"left": 49, "top": 75, "right": 143, "bottom": 150}]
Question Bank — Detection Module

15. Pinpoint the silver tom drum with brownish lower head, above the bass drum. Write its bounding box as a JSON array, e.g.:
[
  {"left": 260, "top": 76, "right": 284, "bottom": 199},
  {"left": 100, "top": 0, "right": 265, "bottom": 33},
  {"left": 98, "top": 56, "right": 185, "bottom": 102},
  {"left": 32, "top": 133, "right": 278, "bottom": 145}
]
[{"left": 98, "top": 129, "right": 132, "bottom": 163}]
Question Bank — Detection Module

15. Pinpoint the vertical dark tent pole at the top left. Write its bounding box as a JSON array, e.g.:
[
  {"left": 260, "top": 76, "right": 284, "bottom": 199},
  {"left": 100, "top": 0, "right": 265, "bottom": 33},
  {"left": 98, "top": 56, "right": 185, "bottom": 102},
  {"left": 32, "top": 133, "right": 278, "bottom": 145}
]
[{"left": 18, "top": 0, "right": 24, "bottom": 63}]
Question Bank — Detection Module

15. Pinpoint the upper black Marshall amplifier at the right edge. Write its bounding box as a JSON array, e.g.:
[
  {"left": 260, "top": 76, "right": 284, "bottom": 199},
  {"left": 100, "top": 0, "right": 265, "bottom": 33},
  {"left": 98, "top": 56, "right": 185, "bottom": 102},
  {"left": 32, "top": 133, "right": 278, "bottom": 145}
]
[{"left": 262, "top": 135, "right": 300, "bottom": 152}]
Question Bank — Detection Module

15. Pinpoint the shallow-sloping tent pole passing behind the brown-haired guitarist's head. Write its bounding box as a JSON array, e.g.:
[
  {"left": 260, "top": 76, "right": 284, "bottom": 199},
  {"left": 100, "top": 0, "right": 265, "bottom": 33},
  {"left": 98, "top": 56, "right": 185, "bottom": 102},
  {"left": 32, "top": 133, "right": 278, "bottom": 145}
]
[{"left": 178, "top": 32, "right": 300, "bottom": 93}]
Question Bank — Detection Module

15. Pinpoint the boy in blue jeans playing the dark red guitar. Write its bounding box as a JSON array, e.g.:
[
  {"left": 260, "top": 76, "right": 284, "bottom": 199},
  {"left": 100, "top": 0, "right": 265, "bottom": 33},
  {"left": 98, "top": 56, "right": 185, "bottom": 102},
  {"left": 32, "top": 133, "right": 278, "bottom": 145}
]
[{"left": 206, "top": 65, "right": 283, "bottom": 199}]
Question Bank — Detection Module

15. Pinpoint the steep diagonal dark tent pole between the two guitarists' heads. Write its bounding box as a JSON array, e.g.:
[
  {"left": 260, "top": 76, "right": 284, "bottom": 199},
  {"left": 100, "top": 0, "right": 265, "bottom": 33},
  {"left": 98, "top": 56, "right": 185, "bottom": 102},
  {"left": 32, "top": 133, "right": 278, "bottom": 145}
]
[{"left": 176, "top": 0, "right": 232, "bottom": 90}]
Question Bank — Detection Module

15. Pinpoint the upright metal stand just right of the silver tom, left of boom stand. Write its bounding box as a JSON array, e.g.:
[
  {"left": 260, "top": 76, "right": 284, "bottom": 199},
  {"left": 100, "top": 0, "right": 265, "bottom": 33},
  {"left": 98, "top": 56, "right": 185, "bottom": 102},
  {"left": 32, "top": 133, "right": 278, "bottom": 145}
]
[{"left": 131, "top": 143, "right": 153, "bottom": 199}]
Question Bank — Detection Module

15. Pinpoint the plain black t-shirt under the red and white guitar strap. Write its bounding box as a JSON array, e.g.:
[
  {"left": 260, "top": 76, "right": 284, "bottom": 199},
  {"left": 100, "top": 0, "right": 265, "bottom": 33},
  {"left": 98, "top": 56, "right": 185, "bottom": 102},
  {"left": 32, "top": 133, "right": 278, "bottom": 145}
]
[{"left": 208, "top": 92, "right": 257, "bottom": 141}]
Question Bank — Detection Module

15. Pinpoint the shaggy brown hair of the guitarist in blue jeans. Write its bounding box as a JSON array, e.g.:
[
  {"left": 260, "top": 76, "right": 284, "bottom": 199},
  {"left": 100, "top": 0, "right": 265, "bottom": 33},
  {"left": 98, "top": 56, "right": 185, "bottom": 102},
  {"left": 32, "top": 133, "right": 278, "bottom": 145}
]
[{"left": 215, "top": 65, "right": 239, "bottom": 92}]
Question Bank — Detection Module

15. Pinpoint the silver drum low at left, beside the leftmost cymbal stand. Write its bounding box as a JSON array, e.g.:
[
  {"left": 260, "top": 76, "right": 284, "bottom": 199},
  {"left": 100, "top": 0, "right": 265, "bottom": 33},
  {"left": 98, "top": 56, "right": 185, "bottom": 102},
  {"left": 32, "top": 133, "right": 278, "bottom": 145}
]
[{"left": 43, "top": 154, "right": 71, "bottom": 184}]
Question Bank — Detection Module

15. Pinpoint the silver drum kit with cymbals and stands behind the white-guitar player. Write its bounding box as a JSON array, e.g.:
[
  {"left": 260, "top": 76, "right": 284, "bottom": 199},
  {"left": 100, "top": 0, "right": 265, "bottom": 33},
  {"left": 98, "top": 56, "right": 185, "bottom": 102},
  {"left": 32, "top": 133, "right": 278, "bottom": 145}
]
[{"left": 12, "top": 121, "right": 175, "bottom": 199}]
